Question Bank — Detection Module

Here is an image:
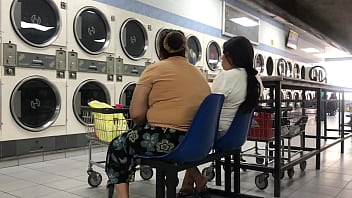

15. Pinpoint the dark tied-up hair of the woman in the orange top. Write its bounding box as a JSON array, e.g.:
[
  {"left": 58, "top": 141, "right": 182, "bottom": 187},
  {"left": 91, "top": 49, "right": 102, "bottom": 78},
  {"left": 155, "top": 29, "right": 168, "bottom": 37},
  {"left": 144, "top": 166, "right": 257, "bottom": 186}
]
[{"left": 158, "top": 29, "right": 187, "bottom": 59}]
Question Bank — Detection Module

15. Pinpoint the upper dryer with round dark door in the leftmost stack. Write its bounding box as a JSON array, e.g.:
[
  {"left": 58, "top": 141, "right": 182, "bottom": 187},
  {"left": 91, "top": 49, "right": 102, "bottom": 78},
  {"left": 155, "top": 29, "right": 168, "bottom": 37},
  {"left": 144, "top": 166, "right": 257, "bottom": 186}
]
[{"left": 0, "top": 0, "right": 67, "bottom": 55}]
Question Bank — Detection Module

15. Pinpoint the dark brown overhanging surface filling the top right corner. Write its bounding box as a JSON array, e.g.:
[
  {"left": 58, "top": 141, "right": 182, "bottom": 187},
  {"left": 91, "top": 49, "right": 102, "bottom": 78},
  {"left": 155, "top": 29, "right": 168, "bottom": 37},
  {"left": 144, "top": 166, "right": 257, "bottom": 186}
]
[{"left": 240, "top": 0, "right": 352, "bottom": 56}]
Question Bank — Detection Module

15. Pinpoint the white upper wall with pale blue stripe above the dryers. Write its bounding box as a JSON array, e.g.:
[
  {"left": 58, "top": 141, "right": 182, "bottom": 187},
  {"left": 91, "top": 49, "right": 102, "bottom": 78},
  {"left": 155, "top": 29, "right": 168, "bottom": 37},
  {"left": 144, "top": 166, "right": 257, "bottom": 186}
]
[{"left": 98, "top": 0, "right": 324, "bottom": 63}]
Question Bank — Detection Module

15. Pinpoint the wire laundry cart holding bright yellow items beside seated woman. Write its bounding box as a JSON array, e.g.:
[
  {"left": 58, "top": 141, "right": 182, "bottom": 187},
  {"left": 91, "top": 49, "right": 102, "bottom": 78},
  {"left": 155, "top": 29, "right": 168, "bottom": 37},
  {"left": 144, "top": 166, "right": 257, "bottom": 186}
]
[{"left": 82, "top": 107, "right": 153, "bottom": 187}]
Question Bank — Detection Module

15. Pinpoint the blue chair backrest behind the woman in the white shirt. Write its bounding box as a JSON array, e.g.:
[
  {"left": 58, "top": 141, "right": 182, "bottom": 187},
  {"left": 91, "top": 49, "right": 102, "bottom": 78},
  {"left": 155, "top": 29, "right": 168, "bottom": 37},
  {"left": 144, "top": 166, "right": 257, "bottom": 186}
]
[{"left": 214, "top": 111, "right": 253, "bottom": 151}]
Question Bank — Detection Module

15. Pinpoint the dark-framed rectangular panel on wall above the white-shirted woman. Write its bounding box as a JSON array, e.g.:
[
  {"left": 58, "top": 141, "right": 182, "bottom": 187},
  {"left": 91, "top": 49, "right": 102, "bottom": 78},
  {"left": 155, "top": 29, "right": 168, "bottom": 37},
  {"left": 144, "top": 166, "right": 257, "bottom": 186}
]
[{"left": 222, "top": 1, "right": 260, "bottom": 44}]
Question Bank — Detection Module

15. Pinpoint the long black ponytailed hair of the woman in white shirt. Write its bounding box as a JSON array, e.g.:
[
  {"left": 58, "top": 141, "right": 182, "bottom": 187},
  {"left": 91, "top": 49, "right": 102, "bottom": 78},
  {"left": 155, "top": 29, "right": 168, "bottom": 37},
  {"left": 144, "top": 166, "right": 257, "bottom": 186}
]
[{"left": 223, "top": 36, "right": 260, "bottom": 113}]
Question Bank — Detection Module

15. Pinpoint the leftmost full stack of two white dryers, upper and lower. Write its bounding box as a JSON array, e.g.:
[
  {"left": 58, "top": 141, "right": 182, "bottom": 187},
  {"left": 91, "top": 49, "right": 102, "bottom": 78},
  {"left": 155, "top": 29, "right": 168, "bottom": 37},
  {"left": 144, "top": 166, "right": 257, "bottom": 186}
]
[{"left": 0, "top": 0, "right": 67, "bottom": 157}]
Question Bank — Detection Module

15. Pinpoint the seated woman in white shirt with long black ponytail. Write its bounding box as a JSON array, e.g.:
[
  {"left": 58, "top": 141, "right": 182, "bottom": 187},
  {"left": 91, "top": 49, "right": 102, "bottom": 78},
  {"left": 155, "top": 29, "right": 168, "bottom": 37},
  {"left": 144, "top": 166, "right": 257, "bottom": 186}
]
[{"left": 179, "top": 36, "right": 263, "bottom": 198}]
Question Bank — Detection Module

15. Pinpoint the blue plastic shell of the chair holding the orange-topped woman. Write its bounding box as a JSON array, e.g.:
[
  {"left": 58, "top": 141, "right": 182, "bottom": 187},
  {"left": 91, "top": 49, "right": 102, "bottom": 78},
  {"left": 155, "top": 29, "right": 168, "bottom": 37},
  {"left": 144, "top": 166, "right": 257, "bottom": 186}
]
[{"left": 159, "top": 94, "right": 224, "bottom": 163}]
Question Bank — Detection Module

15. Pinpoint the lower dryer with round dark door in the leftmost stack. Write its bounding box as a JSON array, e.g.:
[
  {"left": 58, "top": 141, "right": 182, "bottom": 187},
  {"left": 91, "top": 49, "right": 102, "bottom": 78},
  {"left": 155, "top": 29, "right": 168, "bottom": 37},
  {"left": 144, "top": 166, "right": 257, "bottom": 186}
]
[{"left": 1, "top": 43, "right": 66, "bottom": 141}]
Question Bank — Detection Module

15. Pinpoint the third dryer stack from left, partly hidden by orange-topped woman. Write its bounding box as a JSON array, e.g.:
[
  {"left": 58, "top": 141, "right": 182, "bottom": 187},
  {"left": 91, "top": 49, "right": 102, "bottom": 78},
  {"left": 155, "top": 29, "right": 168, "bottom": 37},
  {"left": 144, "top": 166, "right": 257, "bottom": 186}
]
[{"left": 115, "top": 9, "right": 152, "bottom": 107}]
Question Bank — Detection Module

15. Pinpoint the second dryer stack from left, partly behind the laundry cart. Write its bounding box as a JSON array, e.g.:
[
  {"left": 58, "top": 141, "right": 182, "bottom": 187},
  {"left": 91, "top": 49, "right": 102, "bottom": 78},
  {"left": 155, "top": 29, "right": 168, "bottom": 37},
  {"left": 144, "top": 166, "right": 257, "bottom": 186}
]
[{"left": 67, "top": 0, "right": 117, "bottom": 142}]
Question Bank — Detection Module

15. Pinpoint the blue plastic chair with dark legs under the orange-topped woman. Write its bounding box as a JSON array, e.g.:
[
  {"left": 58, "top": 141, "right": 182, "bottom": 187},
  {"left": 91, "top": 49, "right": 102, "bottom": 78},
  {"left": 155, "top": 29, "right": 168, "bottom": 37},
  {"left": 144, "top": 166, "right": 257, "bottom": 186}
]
[{"left": 138, "top": 94, "right": 224, "bottom": 198}]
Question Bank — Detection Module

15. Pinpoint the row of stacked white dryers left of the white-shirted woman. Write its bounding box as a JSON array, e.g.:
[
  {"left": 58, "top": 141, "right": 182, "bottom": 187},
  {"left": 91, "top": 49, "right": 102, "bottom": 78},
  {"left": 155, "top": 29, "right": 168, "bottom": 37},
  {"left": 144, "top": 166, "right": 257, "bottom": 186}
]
[{"left": 0, "top": 0, "right": 226, "bottom": 157}]
